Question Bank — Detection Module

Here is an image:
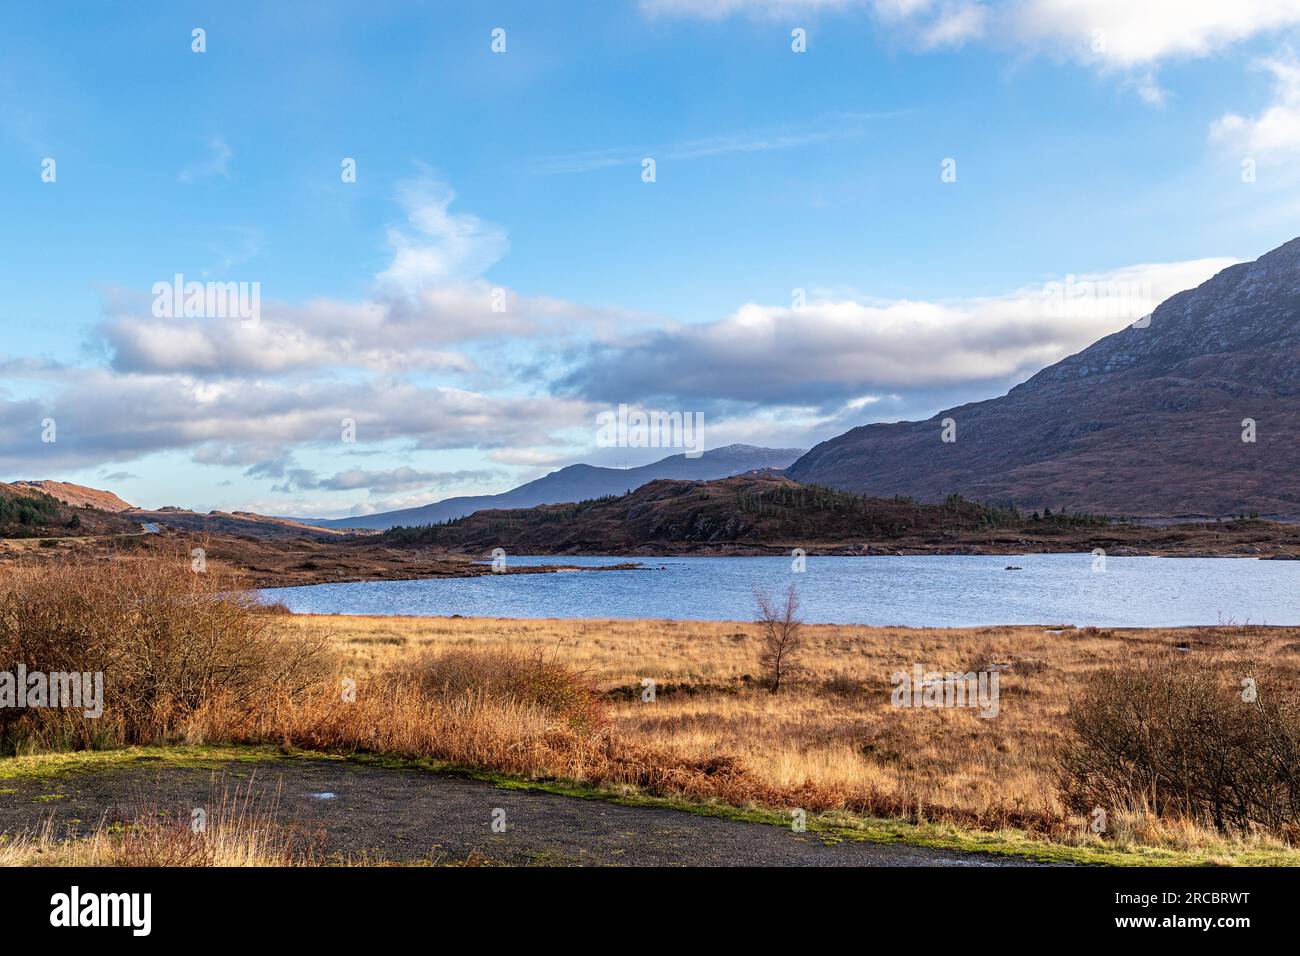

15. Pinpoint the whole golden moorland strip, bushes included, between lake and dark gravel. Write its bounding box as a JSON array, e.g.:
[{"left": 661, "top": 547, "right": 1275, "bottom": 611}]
[{"left": 0, "top": 554, "right": 1300, "bottom": 864}]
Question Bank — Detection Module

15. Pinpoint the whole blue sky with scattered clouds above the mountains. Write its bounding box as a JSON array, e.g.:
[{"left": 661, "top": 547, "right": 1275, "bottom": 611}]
[{"left": 0, "top": 0, "right": 1300, "bottom": 515}]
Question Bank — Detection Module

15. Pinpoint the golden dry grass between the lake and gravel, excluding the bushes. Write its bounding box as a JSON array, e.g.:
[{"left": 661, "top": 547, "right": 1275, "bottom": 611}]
[{"left": 286, "top": 615, "right": 1300, "bottom": 845}]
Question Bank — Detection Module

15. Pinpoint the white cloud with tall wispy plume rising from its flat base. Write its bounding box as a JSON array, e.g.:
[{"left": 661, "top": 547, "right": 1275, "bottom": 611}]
[{"left": 92, "top": 174, "right": 628, "bottom": 377}]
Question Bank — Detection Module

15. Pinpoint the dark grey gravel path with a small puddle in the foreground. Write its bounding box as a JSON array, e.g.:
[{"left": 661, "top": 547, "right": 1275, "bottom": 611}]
[{"left": 0, "top": 760, "right": 1040, "bottom": 866}]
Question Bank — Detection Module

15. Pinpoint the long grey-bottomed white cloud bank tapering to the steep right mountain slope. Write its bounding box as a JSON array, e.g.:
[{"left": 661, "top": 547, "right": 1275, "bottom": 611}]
[{"left": 564, "top": 259, "right": 1232, "bottom": 408}]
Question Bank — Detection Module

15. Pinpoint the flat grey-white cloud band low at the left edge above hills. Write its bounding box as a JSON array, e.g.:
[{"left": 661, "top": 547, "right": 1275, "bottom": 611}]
[{"left": 0, "top": 369, "right": 593, "bottom": 472}]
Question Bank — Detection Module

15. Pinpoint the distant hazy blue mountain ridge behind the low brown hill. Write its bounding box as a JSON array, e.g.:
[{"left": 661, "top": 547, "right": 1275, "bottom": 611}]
[{"left": 291, "top": 445, "right": 803, "bottom": 529}]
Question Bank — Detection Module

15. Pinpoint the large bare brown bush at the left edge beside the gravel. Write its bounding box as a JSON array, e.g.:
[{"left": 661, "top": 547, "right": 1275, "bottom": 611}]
[{"left": 0, "top": 551, "right": 325, "bottom": 753}]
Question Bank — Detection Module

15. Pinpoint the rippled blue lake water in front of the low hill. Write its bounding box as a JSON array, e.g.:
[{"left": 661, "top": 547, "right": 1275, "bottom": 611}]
[{"left": 264, "top": 554, "right": 1300, "bottom": 627}]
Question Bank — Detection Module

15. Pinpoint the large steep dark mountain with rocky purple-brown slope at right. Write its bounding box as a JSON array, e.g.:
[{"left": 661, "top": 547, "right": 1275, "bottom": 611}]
[{"left": 785, "top": 239, "right": 1300, "bottom": 516}]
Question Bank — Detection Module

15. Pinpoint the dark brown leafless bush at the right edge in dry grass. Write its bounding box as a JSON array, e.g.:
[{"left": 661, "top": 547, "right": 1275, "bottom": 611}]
[{"left": 1058, "top": 652, "right": 1300, "bottom": 832}]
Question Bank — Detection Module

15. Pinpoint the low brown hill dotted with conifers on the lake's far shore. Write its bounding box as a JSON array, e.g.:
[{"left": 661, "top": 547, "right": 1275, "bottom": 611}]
[{"left": 377, "top": 472, "right": 1300, "bottom": 556}]
